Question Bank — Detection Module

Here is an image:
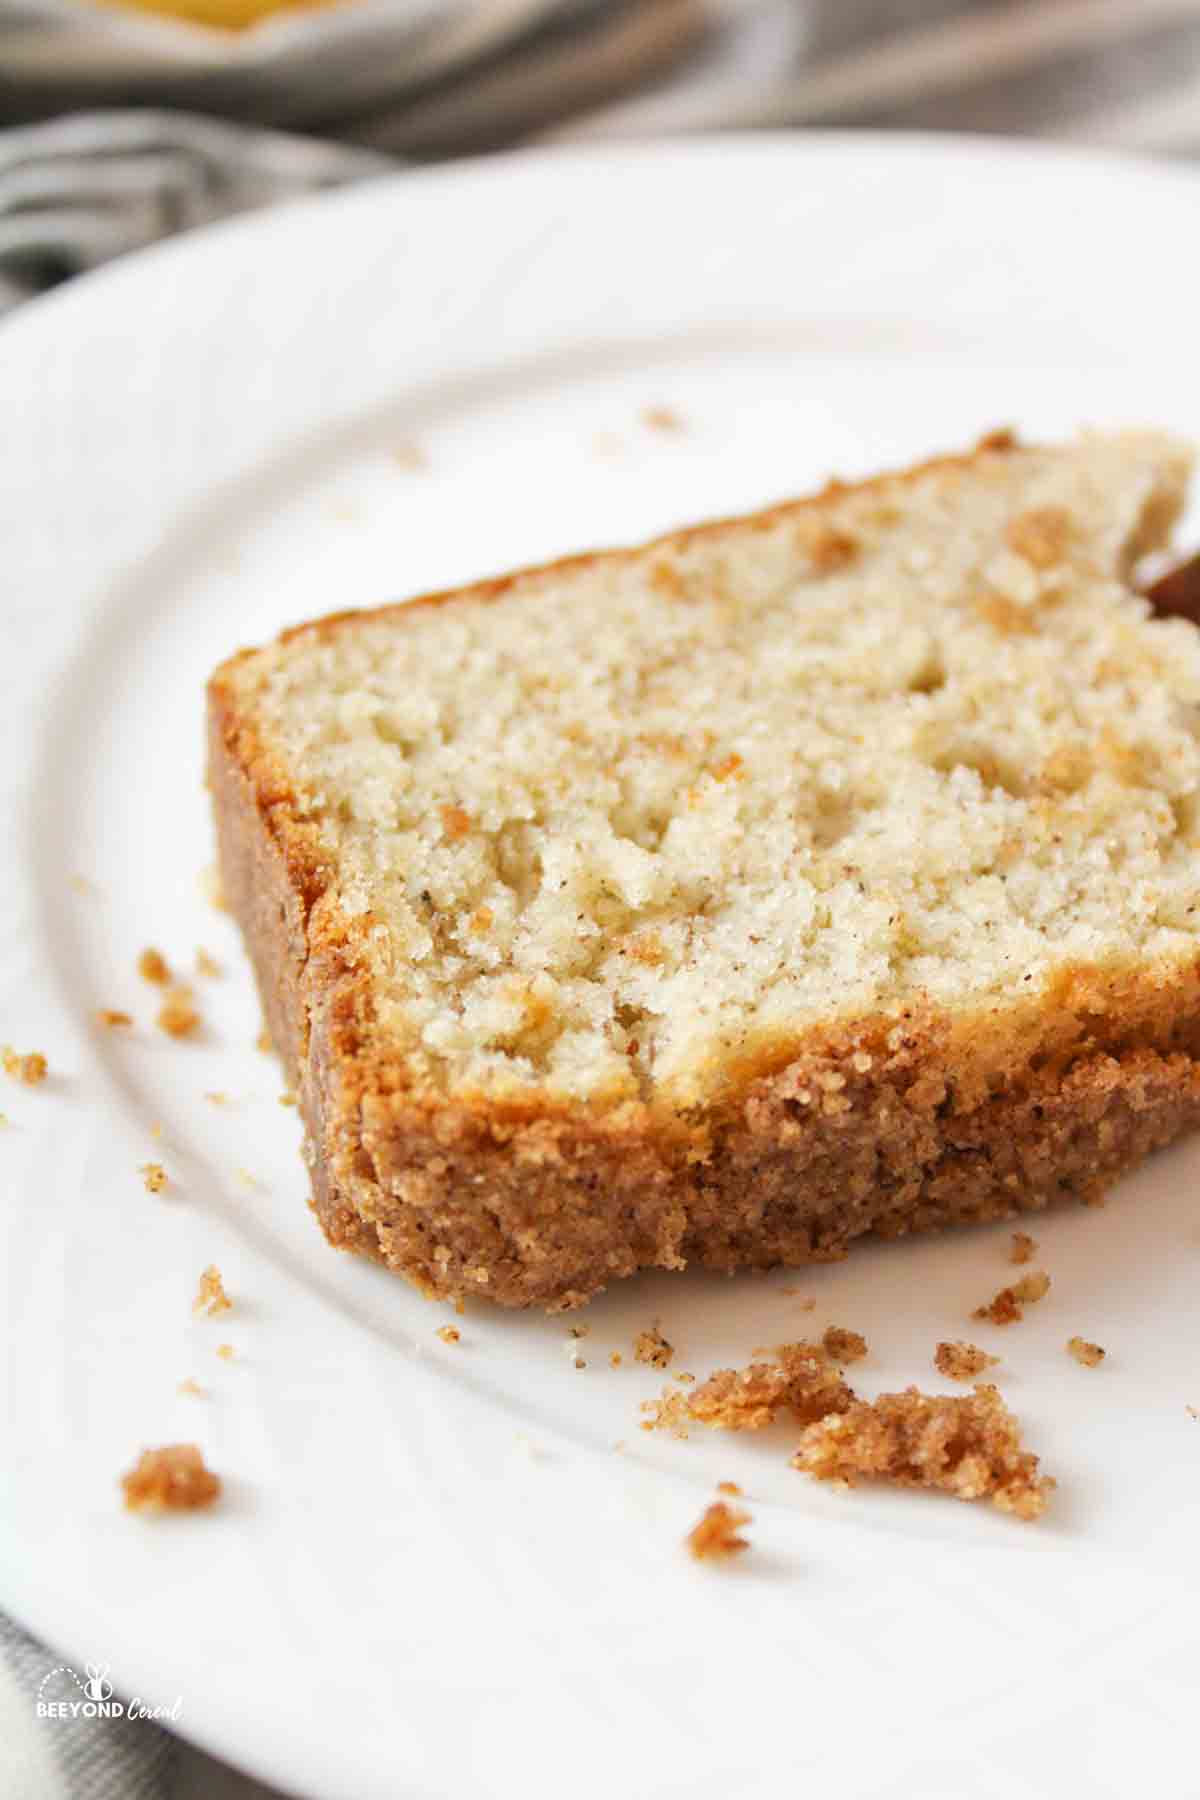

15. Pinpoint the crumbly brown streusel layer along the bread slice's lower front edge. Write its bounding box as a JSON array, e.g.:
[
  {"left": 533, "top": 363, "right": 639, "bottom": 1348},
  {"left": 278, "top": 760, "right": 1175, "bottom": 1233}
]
[{"left": 309, "top": 1051, "right": 1200, "bottom": 1310}]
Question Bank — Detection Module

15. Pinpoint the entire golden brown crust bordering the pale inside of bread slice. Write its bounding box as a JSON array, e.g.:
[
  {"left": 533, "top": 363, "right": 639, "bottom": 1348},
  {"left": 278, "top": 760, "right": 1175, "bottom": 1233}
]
[{"left": 209, "top": 441, "right": 1200, "bottom": 1310}]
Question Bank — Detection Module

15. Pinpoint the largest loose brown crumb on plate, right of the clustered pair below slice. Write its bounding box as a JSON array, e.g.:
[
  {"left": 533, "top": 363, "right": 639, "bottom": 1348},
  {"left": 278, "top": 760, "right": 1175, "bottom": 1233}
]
[{"left": 792, "top": 1382, "right": 1054, "bottom": 1519}]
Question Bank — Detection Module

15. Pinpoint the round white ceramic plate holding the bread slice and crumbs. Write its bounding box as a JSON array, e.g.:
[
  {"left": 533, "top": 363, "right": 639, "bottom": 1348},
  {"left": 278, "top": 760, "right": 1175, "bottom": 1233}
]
[{"left": 0, "top": 137, "right": 1200, "bottom": 1800}]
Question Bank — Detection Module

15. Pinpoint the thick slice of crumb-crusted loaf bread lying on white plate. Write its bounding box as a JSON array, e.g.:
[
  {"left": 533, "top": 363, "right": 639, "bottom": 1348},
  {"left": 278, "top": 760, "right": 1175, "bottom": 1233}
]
[{"left": 209, "top": 434, "right": 1200, "bottom": 1307}]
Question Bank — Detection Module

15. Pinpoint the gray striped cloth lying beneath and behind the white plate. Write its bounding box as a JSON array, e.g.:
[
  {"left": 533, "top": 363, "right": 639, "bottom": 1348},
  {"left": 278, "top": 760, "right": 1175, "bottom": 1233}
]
[{"left": 0, "top": 0, "right": 1200, "bottom": 1800}]
